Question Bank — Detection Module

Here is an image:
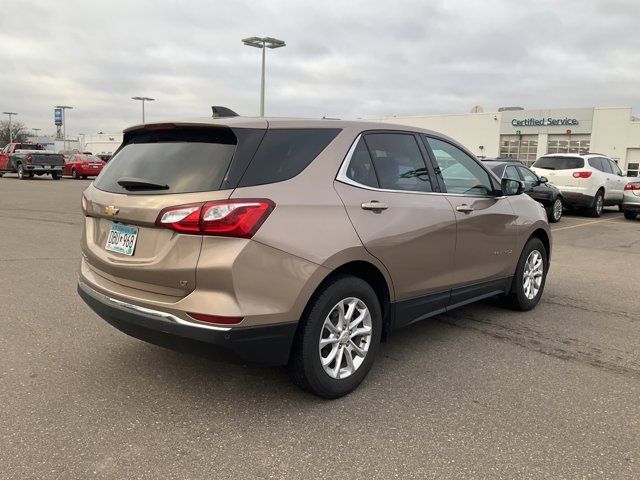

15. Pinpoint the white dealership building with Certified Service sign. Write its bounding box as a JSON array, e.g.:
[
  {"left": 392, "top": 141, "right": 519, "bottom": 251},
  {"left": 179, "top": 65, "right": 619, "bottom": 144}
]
[{"left": 382, "top": 107, "right": 640, "bottom": 177}]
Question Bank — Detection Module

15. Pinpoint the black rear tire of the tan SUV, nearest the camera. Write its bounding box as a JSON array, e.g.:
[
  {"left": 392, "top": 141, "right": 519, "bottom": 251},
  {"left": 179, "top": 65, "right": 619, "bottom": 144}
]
[{"left": 287, "top": 275, "right": 382, "bottom": 399}]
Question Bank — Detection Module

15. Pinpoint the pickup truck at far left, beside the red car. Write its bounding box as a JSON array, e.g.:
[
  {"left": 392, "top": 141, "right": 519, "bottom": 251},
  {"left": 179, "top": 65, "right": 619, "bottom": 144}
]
[{"left": 0, "top": 143, "right": 64, "bottom": 180}]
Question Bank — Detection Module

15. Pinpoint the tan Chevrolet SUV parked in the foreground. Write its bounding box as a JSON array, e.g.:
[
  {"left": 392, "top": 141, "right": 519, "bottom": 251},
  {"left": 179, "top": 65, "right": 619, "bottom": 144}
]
[{"left": 78, "top": 117, "right": 551, "bottom": 398}]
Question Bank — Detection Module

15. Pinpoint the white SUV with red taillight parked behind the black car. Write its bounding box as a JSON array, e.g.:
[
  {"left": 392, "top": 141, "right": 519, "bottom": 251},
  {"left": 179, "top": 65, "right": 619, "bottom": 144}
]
[{"left": 531, "top": 153, "right": 628, "bottom": 217}]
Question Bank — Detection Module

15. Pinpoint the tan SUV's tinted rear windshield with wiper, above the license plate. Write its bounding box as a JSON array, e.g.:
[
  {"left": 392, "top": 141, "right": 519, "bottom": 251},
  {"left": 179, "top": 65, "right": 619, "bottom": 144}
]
[{"left": 94, "top": 127, "right": 236, "bottom": 195}]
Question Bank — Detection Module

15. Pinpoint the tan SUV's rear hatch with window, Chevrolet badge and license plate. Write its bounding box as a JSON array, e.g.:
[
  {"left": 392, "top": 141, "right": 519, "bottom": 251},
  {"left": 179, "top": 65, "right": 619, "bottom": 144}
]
[{"left": 83, "top": 125, "right": 264, "bottom": 297}]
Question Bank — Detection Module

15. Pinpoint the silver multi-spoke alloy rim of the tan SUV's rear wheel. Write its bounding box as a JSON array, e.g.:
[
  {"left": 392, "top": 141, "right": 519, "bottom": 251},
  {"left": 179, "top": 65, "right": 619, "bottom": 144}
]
[{"left": 319, "top": 297, "right": 372, "bottom": 380}]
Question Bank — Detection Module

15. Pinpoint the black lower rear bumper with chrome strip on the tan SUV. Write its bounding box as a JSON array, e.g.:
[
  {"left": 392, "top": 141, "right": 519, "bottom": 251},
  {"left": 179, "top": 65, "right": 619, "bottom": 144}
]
[{"left": 78, "top": 281, "right": 297, "bottom": 365}]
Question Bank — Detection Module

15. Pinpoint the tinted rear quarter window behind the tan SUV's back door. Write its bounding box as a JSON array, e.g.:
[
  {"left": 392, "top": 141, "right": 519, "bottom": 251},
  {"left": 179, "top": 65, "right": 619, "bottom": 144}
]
[{"left": 238, "top": 128, "right": 340, "bottom": 187}]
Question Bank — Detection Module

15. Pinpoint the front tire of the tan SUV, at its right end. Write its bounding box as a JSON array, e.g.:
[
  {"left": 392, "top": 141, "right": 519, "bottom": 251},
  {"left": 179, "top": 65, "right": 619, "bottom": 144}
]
[{"left": 506, "top": 237, "right": 548, "bottom": 311}]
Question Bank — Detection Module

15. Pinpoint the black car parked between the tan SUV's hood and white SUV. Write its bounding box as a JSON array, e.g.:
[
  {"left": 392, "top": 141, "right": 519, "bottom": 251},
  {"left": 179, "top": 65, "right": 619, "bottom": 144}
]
[{"left": 483, "top": 158, "right": 563, "bottom": 222}]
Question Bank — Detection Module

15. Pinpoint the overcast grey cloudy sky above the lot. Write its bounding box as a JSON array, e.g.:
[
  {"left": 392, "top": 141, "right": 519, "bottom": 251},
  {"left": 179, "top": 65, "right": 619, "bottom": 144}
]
[{"left": 0, "top": 0, "right": 640, "bottom": 135}]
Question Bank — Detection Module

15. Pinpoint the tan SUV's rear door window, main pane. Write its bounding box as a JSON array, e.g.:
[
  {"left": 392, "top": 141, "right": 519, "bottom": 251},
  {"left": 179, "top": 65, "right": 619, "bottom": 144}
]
[{"left": 364, "top": 133, "right": 433, "bottom": 192}]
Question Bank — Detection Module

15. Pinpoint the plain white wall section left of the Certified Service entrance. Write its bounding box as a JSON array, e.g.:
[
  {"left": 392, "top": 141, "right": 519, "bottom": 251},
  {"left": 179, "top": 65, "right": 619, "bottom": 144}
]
[{"left": 381, "top": 113, "right": 501, "bottom": 157}]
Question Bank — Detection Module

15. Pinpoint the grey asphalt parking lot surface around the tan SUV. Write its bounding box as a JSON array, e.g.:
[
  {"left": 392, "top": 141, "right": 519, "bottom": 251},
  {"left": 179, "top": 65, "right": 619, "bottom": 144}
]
[{"left": 0, "top": 175, "right": 640, "bottom": 479}]
